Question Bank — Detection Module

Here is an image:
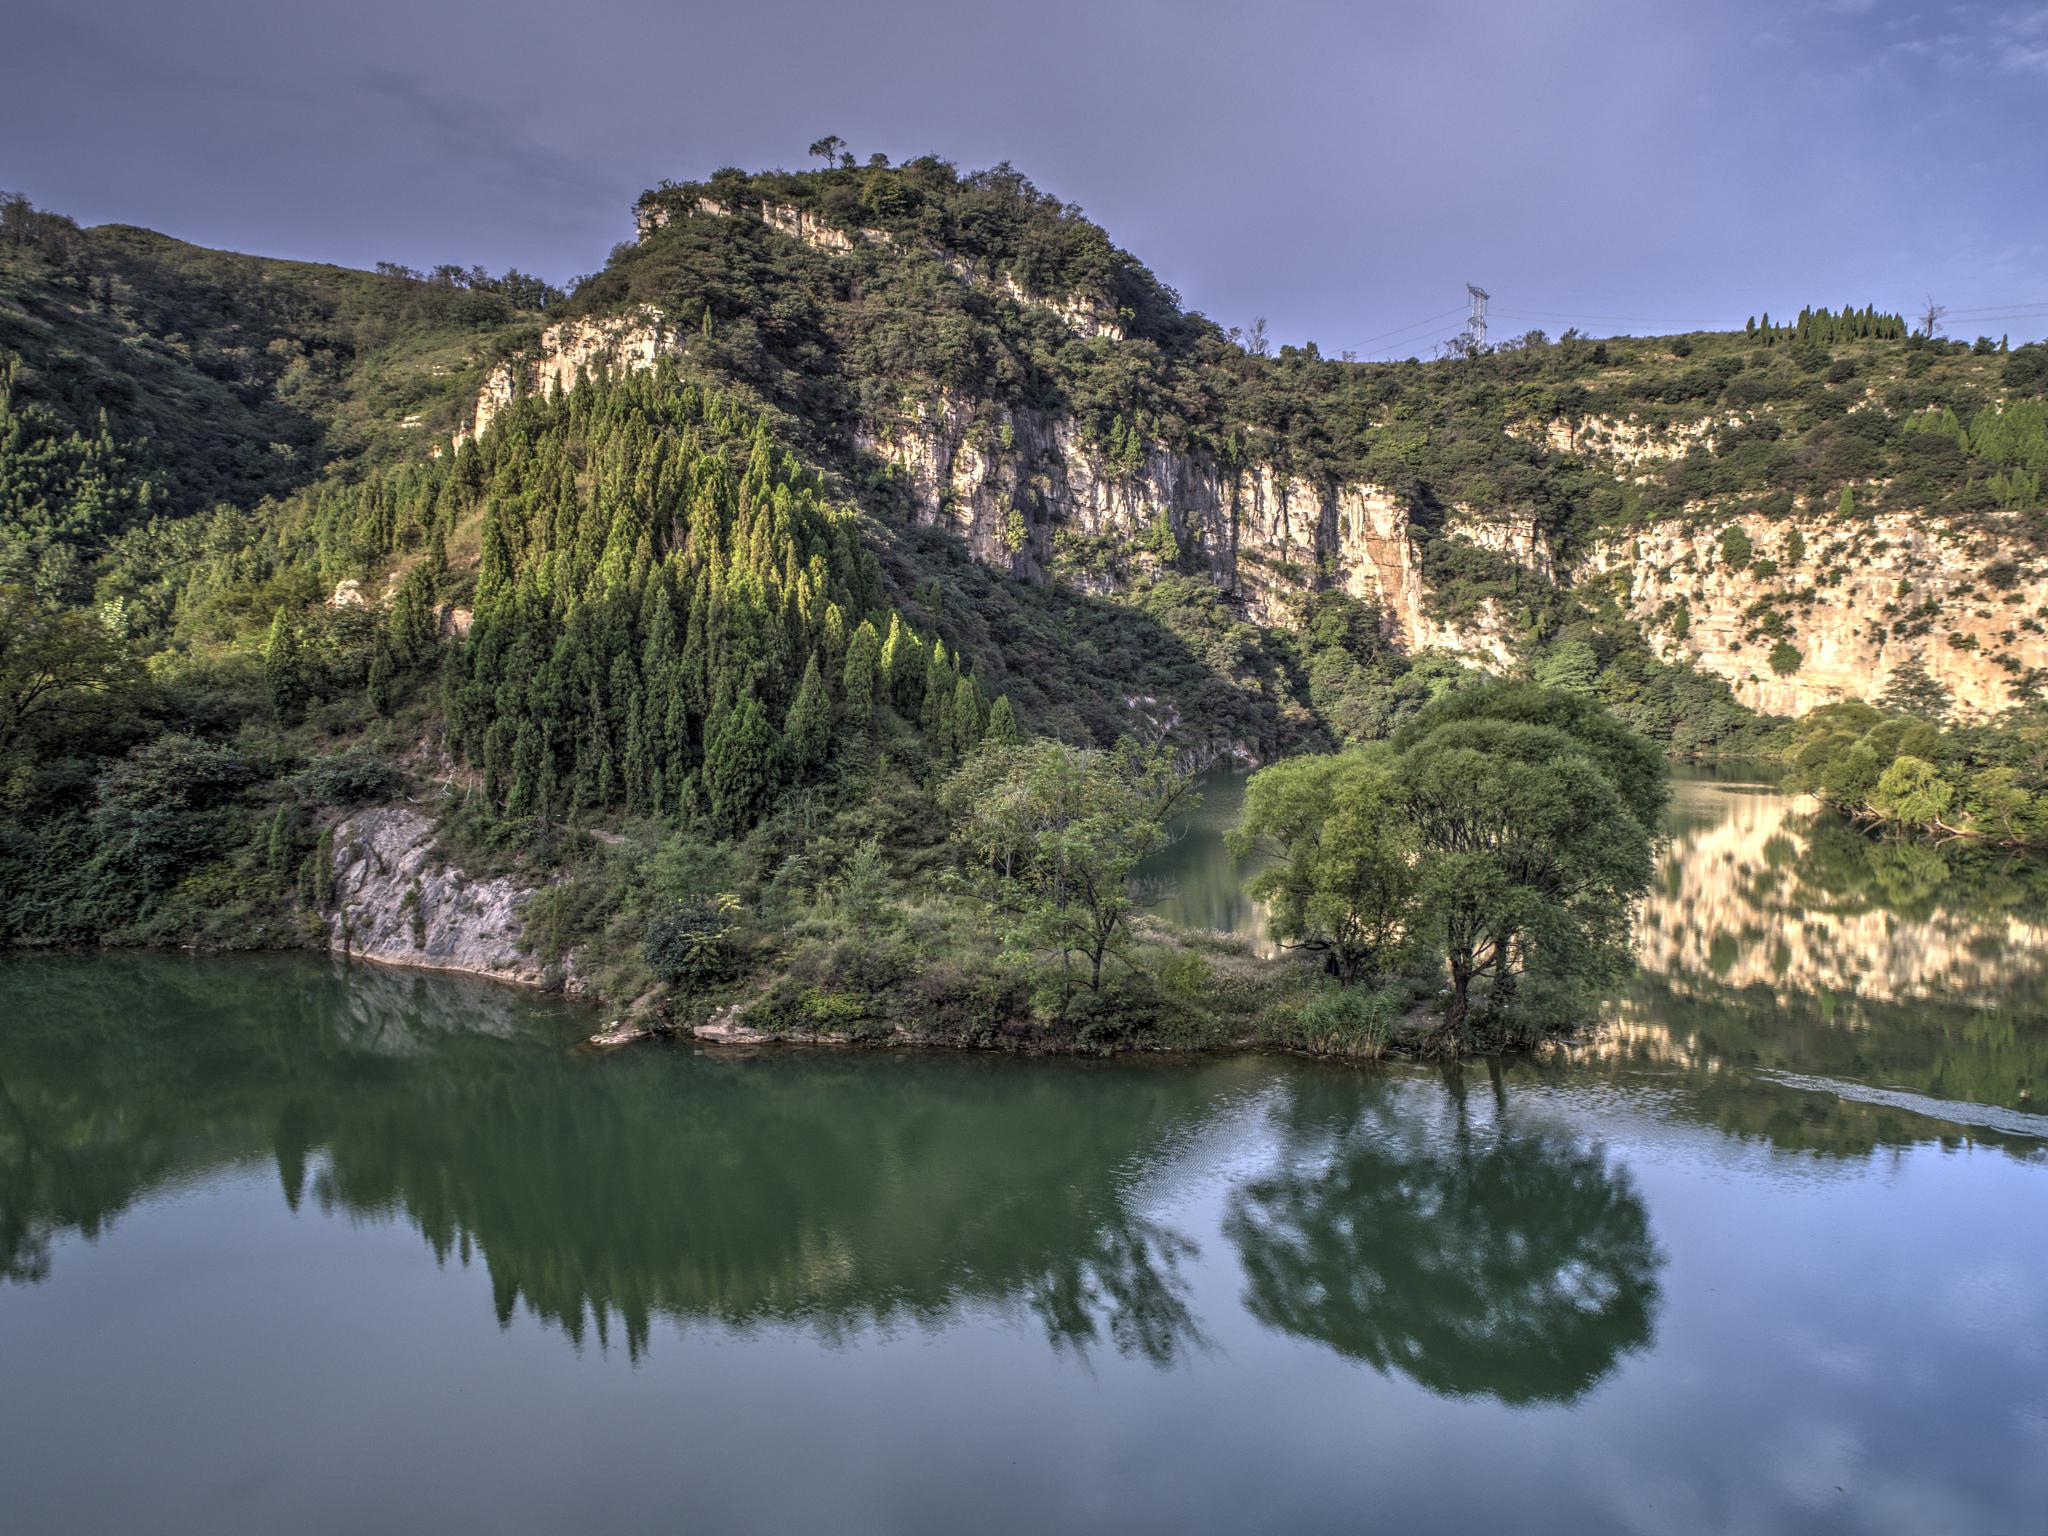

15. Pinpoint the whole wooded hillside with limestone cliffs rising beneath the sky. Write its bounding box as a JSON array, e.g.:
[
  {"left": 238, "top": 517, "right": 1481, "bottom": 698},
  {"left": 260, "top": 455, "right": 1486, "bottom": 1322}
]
[{"left": 0, "top": 158, "right": 2048, "bottom": 1028}]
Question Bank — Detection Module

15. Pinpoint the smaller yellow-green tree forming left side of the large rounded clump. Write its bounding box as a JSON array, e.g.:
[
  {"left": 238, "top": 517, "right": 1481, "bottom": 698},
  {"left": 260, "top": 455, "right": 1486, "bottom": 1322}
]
[{"left": 1227, "top": 748, "right": 1417, "bottom": 985}]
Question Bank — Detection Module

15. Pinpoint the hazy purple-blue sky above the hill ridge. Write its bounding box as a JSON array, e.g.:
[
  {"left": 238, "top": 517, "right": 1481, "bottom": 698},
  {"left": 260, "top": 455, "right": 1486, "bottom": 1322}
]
[{"left": 12, "top": 0, "right": 2048, "bottom": 356}]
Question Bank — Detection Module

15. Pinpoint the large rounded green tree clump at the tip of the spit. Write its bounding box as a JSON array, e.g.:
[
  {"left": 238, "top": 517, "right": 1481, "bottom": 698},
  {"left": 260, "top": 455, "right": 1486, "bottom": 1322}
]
[{"left": 1231, "top": 682, "right": 1669, "bottom": 1053}]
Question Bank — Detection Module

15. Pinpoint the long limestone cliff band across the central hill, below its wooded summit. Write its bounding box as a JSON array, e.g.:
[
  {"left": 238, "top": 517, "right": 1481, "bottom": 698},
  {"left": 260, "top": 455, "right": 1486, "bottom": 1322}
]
[{"left": 858, "top": 393, "right": 1550, "bottom": 664}]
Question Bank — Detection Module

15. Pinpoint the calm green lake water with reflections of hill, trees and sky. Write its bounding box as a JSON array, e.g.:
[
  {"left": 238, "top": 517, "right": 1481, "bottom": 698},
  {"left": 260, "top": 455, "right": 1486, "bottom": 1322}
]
[{"left": 0, "top": 782, "right": 2048, "bottom": 1534}]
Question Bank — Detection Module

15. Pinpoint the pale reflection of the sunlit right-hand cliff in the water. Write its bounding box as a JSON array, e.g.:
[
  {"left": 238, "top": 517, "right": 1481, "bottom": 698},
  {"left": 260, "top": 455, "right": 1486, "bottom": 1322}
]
[{"left": 1583, "top": 780, "right": 2048, "bottom": 1153}]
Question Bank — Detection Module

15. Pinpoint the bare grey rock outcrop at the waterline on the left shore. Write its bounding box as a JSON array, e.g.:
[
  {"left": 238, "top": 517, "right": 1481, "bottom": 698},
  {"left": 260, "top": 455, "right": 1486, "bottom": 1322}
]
[{"left": 328, "top": 807, "right": 557, "bottom": 985}]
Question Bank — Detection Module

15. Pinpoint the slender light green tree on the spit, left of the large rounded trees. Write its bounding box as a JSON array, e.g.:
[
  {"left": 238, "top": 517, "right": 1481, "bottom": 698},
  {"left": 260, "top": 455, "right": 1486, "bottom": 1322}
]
[{"left": 942, "top": 737, "right": 1198, "bottom": 991}]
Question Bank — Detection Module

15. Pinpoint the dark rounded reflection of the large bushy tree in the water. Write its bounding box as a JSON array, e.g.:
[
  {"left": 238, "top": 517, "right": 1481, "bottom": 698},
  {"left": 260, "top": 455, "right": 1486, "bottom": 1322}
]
[{"left": 1225, "top": 1077, "right": 1661, "bottom": 1405}]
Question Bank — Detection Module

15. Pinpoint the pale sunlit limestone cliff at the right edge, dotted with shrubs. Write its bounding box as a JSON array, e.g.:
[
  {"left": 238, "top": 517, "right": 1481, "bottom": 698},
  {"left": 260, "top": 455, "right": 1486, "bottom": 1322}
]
[{"left": 1579, "top": 512, "right": 2048, "bottom": 719}]
